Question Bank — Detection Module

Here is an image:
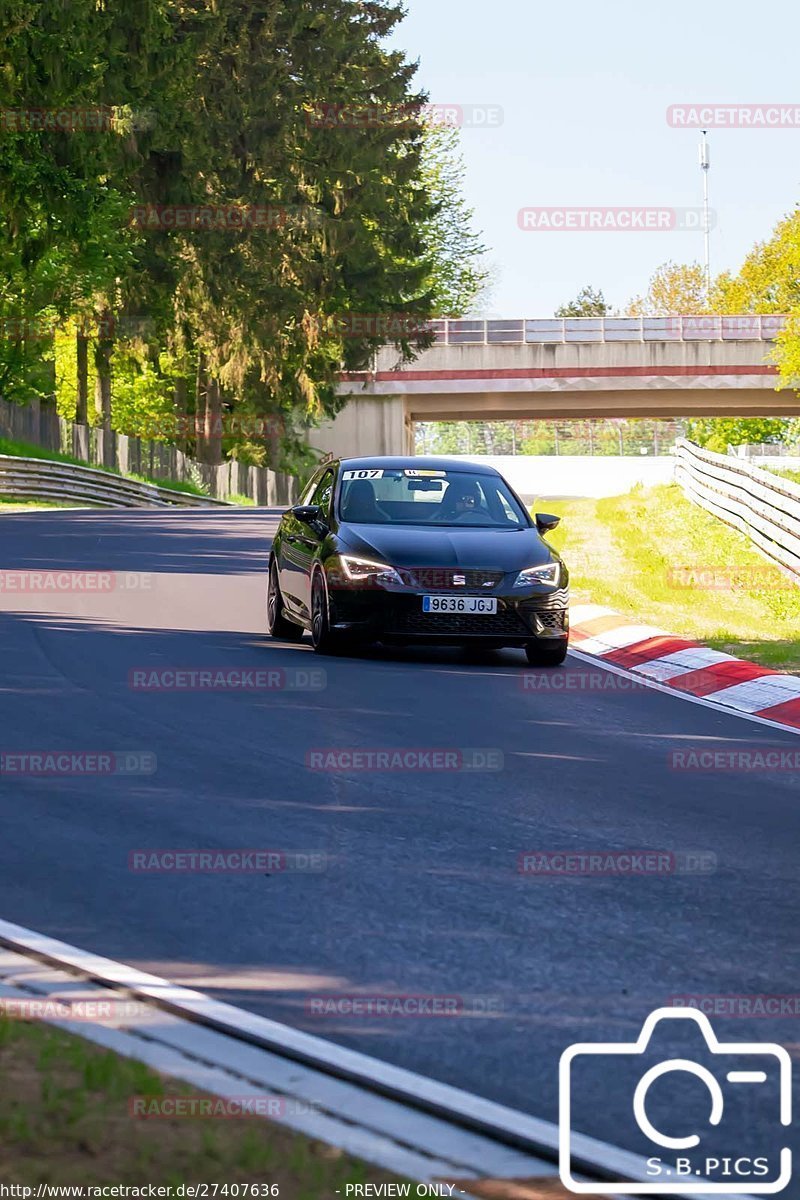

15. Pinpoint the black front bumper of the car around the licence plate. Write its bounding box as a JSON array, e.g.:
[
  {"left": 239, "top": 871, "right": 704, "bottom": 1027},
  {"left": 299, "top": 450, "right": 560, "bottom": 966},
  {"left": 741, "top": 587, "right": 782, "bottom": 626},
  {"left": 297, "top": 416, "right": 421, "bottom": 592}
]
[{"left": 329, "top": 584, "right": 570, "bottom": 646}]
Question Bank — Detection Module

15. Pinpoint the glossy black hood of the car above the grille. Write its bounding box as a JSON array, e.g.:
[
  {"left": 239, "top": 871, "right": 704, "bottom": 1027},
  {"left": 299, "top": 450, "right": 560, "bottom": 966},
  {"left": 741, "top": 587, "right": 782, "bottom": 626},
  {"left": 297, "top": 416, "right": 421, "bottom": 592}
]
[{"left": 338, "top": 524, "right": 558, "bottom": 572}]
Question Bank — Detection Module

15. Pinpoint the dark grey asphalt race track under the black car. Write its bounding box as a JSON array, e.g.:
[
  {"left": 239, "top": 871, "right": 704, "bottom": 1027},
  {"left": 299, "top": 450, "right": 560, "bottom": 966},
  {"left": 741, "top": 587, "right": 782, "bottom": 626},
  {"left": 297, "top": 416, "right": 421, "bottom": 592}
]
[{"left": 0, "top": 511, "right": 800, "bottom": 1171}]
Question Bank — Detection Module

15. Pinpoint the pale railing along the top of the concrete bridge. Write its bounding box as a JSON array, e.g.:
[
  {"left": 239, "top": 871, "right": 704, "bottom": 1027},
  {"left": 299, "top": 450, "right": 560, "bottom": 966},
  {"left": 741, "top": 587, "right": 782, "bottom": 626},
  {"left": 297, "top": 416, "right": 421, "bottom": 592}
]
[{"left": 426, "top": 314, "right": 786, "bottom": 346}]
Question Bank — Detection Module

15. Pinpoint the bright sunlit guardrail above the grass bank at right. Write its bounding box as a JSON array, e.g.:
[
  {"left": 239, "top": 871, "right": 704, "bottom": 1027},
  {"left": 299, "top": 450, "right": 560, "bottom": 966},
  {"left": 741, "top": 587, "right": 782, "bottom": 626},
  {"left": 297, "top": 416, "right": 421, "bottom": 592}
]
[{"left": 675, "top": 439, "right": 800, "bottom": 578}]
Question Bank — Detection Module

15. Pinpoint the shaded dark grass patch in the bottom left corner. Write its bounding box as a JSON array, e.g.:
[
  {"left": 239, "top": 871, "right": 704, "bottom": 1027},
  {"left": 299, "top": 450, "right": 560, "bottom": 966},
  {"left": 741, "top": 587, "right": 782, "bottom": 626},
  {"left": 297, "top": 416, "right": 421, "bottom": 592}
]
[{"left": 0, "top": 1016, "right": 412, "bottom": 1200}]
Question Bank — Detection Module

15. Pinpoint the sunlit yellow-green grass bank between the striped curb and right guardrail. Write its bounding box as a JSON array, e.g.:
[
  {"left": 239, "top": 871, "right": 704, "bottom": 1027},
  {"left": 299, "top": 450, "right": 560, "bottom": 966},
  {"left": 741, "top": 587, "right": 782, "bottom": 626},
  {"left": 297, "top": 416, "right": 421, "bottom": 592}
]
[{"left": 539, "top": 484, "right": 800, "bottom": 673}]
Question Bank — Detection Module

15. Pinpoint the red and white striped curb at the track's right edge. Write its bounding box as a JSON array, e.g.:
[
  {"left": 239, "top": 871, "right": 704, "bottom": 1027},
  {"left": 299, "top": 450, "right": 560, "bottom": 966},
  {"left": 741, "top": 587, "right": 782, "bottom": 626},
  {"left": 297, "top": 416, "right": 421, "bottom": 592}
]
[{"left": 570, "top": 605, "right": 800, "bottom": 730}]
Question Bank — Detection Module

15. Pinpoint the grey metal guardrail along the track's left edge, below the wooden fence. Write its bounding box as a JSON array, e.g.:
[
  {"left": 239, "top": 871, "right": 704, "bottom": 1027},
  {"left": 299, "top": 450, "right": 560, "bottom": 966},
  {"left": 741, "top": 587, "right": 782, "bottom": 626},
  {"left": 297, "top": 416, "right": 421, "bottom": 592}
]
[{"left": 0, "top": 455, "right": 230, "bottom": 509}]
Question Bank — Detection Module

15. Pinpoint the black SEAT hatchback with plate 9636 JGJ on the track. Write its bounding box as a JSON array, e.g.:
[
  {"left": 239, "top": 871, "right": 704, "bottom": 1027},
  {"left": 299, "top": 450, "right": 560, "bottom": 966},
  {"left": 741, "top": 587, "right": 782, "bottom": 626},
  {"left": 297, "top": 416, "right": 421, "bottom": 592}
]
[{"left": 266, "top": 457, "right": 570, "bottom": 666}]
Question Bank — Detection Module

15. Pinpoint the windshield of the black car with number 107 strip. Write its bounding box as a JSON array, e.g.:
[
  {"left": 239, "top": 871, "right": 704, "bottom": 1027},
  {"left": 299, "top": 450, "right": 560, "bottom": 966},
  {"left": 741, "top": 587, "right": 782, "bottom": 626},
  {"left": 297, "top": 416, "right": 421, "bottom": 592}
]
[{"left": 338, "top": 468, "right": 529, "bottom": 529}]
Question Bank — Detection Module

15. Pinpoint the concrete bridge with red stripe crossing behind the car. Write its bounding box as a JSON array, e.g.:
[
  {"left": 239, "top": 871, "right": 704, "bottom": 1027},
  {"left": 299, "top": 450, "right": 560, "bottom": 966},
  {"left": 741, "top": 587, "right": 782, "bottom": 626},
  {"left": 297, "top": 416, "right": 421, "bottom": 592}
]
[{"left": 311, "top": 316, "right": 800, "bottom": 455}]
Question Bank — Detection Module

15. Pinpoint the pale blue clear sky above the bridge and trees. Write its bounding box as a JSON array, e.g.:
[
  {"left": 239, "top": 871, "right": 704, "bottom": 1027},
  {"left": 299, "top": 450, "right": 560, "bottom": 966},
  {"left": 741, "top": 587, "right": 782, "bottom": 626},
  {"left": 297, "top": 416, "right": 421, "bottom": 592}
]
[{"left": 392, "top": 0, "right": 800, "bottom": 318}]
